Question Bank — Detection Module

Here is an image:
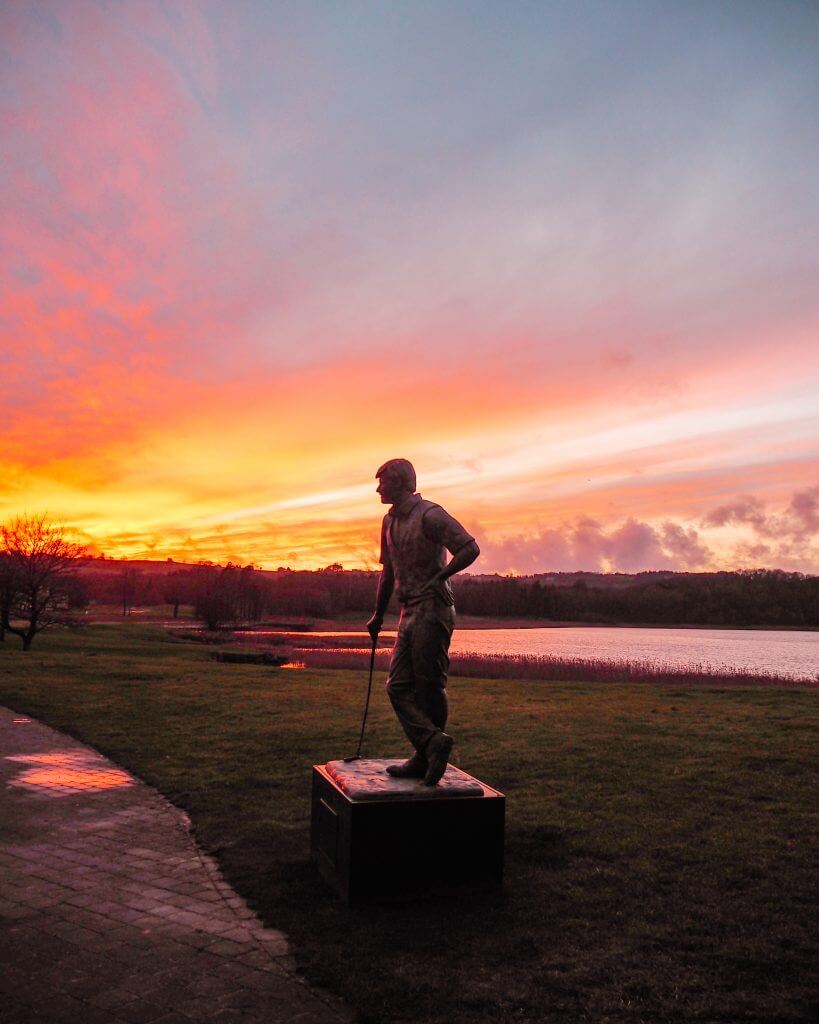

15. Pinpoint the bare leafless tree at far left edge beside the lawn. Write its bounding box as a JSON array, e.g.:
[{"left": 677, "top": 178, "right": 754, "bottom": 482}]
[{"left": 0, "top": 515, "right": 85, "bottom": 650}]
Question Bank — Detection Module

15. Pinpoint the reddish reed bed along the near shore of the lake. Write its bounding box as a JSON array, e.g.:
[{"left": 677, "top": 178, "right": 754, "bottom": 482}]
[{"left": 291, "top": 647, "right": 819, "bottom": 686}]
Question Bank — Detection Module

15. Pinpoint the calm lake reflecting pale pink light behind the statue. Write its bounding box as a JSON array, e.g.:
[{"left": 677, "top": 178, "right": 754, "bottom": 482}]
[{"left": 282, "top": 626, "right": 819, "bottom": 679}]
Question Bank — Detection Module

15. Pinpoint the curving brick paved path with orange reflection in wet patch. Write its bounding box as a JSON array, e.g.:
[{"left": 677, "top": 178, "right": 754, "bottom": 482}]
[{"left": 0, "top": 709, "right": 354, "bottom": 1024}]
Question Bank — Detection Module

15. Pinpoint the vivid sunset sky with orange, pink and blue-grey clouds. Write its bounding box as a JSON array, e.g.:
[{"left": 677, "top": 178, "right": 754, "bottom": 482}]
[{"left": 0, "top": 0, "right": 819, "bottom": 573}]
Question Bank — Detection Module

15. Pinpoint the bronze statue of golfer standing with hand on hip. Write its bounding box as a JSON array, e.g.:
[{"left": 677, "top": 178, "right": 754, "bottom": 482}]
[{"left": 367, "top": 459, "right": 480, "bottom": 785}]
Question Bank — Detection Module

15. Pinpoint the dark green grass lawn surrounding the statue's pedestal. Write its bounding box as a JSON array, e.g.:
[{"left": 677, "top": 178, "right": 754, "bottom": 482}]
[{"left": 0, "top": 625, "right": 819, "bottom": 1024}]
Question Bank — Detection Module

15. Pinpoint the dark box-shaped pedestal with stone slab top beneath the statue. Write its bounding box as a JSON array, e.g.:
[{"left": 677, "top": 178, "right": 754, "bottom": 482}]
[{"left": 310, "top": 759, "right": 506, "bottom": 903}]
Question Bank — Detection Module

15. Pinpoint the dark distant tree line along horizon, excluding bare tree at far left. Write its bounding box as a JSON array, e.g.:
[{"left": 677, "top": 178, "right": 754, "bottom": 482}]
[{"left": 79, "top": 563, "right": 819, "bottom": 629}]
